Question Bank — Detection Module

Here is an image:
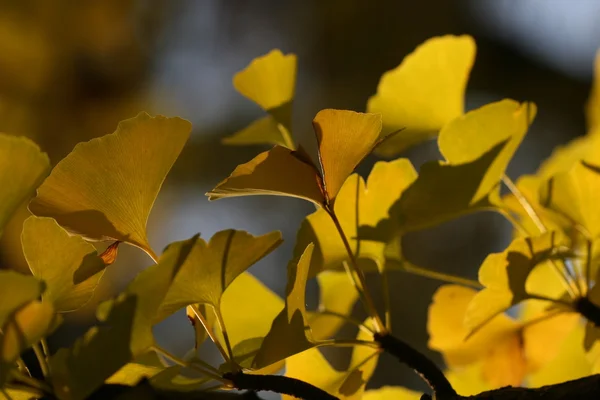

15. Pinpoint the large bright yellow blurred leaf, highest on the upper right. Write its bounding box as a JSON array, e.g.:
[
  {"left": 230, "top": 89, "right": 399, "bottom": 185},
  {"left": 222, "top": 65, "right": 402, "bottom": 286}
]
[{"left": 367, "top": 35, "right": 476, "bottom": 157}]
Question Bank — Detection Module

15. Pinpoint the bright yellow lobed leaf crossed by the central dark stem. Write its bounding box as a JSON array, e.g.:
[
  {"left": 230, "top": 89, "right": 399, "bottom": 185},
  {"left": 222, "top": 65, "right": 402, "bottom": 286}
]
[{"left": 294, "top": 159, "right": 417, "bottom": 276}]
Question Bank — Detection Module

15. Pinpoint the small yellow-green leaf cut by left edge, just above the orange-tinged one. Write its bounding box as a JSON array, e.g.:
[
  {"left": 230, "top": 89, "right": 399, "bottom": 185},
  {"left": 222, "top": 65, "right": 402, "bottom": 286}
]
[{"left": 0, "top": 270, "right": 46, "bottom": 329}]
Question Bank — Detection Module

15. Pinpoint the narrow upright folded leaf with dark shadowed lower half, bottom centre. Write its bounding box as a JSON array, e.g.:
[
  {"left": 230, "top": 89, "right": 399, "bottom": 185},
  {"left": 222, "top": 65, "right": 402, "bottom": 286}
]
[{"left": 253, "top": 244, "right": 314, "bottom": 369}]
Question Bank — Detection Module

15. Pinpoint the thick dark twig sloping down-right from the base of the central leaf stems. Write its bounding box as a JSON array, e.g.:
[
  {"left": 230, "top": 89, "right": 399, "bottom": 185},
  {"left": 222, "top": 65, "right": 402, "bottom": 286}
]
[{"left": 374, "top": 334, "right": 456, "bottom": 399}]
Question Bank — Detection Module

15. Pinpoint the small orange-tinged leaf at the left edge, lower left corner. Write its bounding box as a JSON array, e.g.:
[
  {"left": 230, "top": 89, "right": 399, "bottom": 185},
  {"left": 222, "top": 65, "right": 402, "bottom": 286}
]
[{"left": 0, "top": 300, "right": 57, "bottom": 387}]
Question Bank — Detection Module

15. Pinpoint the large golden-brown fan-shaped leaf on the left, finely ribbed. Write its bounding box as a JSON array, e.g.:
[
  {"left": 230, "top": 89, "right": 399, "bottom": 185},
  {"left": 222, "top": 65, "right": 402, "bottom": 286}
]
[{"left": 29, "top": 113, "right": 191, "bottom": 259}]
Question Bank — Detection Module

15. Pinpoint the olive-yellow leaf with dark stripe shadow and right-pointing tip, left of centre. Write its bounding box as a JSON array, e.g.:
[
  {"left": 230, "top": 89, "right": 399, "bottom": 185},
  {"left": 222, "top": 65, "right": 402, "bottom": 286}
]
[{"left": 155, "top": 229, "right": 282, "bottom": 321}]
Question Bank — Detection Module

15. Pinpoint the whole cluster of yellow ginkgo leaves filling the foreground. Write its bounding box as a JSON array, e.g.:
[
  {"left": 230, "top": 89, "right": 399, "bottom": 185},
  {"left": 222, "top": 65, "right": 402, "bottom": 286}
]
[{"left": 0, "top": 36, "right": 600, "bottom": 400}]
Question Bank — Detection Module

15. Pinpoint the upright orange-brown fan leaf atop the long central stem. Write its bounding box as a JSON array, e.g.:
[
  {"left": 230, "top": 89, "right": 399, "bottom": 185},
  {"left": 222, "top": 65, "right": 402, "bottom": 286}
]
[{"left": 313, "top": 109, "right": 381, "bottom": 202}]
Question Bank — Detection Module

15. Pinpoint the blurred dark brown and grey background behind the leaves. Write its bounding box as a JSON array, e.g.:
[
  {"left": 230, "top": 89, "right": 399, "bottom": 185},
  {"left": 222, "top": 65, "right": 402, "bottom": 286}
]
[{"left": 0, "top": 0, "right": 600, "bottom": 396}]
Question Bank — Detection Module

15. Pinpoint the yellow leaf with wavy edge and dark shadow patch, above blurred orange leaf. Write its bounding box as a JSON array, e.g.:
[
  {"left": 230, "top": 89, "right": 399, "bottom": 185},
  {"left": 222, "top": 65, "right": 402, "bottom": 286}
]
[{"left": 465, "top": 232, "right": 560, "bottom": 329}]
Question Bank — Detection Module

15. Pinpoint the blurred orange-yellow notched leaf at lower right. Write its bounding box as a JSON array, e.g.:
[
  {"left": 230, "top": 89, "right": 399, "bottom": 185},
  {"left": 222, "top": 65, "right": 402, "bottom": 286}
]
[{"left": 427, "top": 285, "right": 526, "bottom": 387}]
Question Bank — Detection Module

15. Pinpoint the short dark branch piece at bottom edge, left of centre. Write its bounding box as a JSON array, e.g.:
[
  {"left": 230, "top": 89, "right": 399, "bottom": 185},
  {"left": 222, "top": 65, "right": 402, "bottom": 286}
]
[{"left": 223, "top": 372, "right": 339, "bottom": 400}]
